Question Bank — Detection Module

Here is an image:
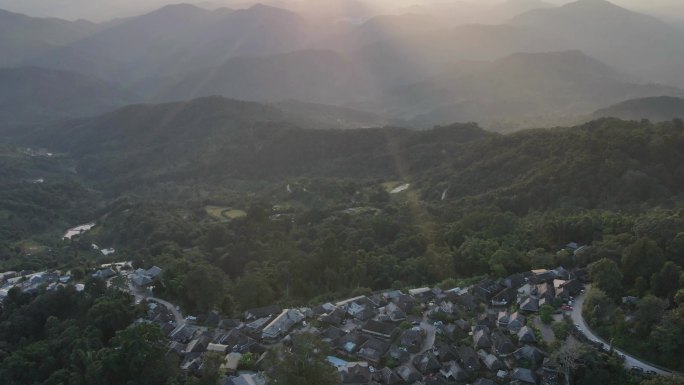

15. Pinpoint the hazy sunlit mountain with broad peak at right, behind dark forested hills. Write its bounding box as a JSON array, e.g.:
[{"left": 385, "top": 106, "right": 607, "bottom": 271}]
[{"left": 360, "top": 51, "right": 684, "bottom": 127}]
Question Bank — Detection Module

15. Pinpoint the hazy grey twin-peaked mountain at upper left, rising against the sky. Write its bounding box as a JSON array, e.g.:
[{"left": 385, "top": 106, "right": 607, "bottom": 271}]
[{"left": 26, "top": 4, "right": 336, "bottom": 84}]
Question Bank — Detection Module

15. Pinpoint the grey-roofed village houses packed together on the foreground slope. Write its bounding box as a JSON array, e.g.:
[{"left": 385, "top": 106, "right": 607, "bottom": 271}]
[{"left": 139, "top": 267, "right": 587, "bottom": 385}]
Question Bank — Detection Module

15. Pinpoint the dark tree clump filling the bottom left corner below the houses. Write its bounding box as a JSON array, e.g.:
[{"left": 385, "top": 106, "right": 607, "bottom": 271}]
[{"left": 0, "top": 281, "right": 184, "bottom": 385}]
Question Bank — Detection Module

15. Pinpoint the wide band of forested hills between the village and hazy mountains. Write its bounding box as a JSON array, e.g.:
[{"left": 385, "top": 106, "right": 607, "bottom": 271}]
[{"left": 0, "top": 98, "right": 684, "bottom": 368}]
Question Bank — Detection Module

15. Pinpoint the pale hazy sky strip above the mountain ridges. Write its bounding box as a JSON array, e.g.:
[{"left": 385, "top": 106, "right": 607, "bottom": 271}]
[{"left": 0, "top": 0, "right": 684, "bottom": 21}]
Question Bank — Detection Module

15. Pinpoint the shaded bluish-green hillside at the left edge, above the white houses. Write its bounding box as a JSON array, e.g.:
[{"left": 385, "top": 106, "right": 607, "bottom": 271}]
[{"left": 0, "top": 145, "right": 101, "bottom": 269}]
